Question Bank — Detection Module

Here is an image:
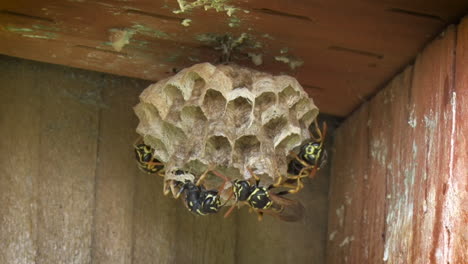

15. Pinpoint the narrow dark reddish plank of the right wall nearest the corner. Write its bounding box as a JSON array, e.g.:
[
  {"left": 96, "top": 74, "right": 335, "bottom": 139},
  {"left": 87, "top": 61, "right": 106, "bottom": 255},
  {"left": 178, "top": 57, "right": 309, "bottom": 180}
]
[{"left": 326, "top": 104, "right": 371, "bottom": 263}]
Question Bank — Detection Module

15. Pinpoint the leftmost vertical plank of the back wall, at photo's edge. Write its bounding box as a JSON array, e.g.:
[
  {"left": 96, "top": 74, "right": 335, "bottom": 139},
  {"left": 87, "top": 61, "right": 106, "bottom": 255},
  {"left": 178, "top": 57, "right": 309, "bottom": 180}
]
[{"left": 0, "top": 56, "right": 41, "bottom": 264}]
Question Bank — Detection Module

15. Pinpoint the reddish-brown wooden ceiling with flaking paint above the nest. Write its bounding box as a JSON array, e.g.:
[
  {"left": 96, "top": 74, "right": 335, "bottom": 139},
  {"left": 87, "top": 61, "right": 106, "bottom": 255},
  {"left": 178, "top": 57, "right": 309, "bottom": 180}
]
[{"left": 0, "top": 0, "right": 468, "bottom": 116}]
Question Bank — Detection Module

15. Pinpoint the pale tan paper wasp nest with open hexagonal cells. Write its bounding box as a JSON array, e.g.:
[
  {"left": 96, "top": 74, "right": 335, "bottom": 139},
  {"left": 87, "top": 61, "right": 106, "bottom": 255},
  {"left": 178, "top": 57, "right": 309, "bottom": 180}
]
[{"left": 134, "top": 63, "right": 318, "bottom": 186}]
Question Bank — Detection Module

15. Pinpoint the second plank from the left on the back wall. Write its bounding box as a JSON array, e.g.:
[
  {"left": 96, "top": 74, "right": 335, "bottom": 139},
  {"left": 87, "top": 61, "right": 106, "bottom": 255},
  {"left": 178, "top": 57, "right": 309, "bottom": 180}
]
[{"left": 34, "top": 65, "right": 100, "bottom": 264}]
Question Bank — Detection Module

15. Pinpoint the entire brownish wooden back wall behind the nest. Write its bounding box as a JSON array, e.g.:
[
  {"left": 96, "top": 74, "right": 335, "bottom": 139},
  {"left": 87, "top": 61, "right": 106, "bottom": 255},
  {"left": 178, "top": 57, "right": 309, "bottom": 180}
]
[{"left": 0, "top": 56, "right": 328, "bottom": 264}]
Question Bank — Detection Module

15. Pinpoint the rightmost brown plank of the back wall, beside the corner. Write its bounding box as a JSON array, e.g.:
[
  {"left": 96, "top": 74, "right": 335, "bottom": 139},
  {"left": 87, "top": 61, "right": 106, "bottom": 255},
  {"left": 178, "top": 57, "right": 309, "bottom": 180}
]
[{"left": 238, "top": 165, "right": 329, "bottom": 264}]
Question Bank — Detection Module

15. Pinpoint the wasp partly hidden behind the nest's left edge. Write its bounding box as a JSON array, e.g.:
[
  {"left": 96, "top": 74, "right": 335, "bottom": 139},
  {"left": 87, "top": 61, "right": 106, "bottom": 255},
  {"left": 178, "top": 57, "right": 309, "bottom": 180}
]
[{"left": 133, "top": 139, "right": 164, "bottom": 176}]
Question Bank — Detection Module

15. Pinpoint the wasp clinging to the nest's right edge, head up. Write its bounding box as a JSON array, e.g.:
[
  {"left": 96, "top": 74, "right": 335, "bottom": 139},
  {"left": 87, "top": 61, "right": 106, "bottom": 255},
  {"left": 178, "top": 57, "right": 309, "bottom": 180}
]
[{"left": 286, "top": 119, "right": 327, "bottom": 193}]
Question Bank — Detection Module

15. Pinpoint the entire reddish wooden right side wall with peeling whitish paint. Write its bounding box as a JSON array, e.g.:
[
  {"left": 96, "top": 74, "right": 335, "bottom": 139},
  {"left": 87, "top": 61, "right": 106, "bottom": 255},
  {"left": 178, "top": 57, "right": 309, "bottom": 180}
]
[{"left": 327, "top": 20, "right": 468, "bottom": 263}]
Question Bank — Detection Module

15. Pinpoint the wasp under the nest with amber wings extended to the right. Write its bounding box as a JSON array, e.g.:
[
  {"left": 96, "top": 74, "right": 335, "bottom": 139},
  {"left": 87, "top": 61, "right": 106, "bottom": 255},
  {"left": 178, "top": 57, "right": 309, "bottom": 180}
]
[{"left": 221, "top": 168, "right": 304, "bottom": 222}]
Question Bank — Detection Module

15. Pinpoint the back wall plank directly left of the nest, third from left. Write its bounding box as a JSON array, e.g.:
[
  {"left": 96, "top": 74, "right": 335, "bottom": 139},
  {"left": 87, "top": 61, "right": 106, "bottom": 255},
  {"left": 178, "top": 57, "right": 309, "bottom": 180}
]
[{"left": 92, "top": 75, "right": 148, "bottom": 264}]
